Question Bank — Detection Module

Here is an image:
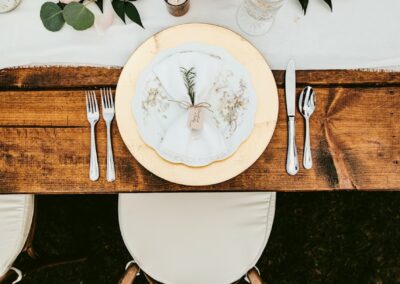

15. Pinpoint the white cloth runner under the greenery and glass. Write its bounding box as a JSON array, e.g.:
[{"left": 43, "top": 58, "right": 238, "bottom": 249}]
[{"left": 0, "top": 0, "right": 400, "bottom": 69}]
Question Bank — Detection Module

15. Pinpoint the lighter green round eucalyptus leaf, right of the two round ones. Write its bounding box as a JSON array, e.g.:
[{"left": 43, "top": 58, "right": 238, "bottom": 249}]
[{"left": 63, "top": 2, "right": 94, "bottom": 31}]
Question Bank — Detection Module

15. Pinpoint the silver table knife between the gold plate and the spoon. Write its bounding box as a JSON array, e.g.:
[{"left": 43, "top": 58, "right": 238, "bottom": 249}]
[{"left": 285, "top": 59, "right": 299, "bottom": 176}]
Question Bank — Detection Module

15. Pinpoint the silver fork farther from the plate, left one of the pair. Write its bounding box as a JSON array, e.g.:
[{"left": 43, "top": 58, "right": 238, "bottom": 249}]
[{"left": 86, "top": 91, "right": 99, "bottom": 181}]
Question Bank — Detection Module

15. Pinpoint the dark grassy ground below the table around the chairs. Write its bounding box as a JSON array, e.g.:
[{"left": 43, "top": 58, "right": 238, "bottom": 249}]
[{"left": 17, "top": 192, "right": 400, "bottom": 284}]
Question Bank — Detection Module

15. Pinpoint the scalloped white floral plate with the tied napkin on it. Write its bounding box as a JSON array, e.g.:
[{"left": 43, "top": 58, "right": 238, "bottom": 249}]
[{"left": 132, "top": 43, "right": 257, "bottom": 167}]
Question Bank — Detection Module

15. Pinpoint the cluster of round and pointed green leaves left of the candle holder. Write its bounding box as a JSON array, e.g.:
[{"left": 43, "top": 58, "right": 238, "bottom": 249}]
[{"left": 40, "top": 0, "right": 143, "bottom": 32}]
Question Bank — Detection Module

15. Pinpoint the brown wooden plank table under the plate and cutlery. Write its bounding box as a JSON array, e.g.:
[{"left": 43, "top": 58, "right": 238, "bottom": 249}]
[{"left": 0, "top": 67, "right": 400, "bottom": 194}]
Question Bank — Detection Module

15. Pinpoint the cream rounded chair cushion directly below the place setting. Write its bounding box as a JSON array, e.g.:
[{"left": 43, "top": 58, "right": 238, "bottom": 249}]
[{"left": 119, "top": 192, "right": 276, "bottom": 284}]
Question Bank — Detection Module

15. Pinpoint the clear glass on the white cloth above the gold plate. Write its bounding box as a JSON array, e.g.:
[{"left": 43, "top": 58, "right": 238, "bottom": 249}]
[{"left": 237, "top": 0, "right": 285, "bottom": 36}]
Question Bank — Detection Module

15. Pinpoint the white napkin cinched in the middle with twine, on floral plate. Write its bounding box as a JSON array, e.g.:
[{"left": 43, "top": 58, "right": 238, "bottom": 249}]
[{"left": 153, "top": 51, "right": 227, "bottom": 165}]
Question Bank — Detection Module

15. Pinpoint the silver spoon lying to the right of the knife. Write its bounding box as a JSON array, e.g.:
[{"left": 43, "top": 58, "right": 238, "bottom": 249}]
[{"left": 299, "top": 86, "right": 316, "bottom": 169}]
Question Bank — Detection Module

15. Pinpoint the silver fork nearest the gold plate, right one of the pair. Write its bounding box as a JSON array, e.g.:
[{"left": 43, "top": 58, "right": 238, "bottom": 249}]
[{"left": 100, "top": 88, "right": 115, "bottom": 182}]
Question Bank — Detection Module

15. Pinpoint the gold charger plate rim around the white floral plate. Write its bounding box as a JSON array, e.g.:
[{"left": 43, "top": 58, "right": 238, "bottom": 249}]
[{"left": 115, "top": 23, "right": 279, "bottom": 186}]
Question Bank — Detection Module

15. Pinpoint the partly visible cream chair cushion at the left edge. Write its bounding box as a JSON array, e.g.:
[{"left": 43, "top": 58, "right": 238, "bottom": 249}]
[{"left": 0, "top": 194, "right": 34, "bottom": 277}]
